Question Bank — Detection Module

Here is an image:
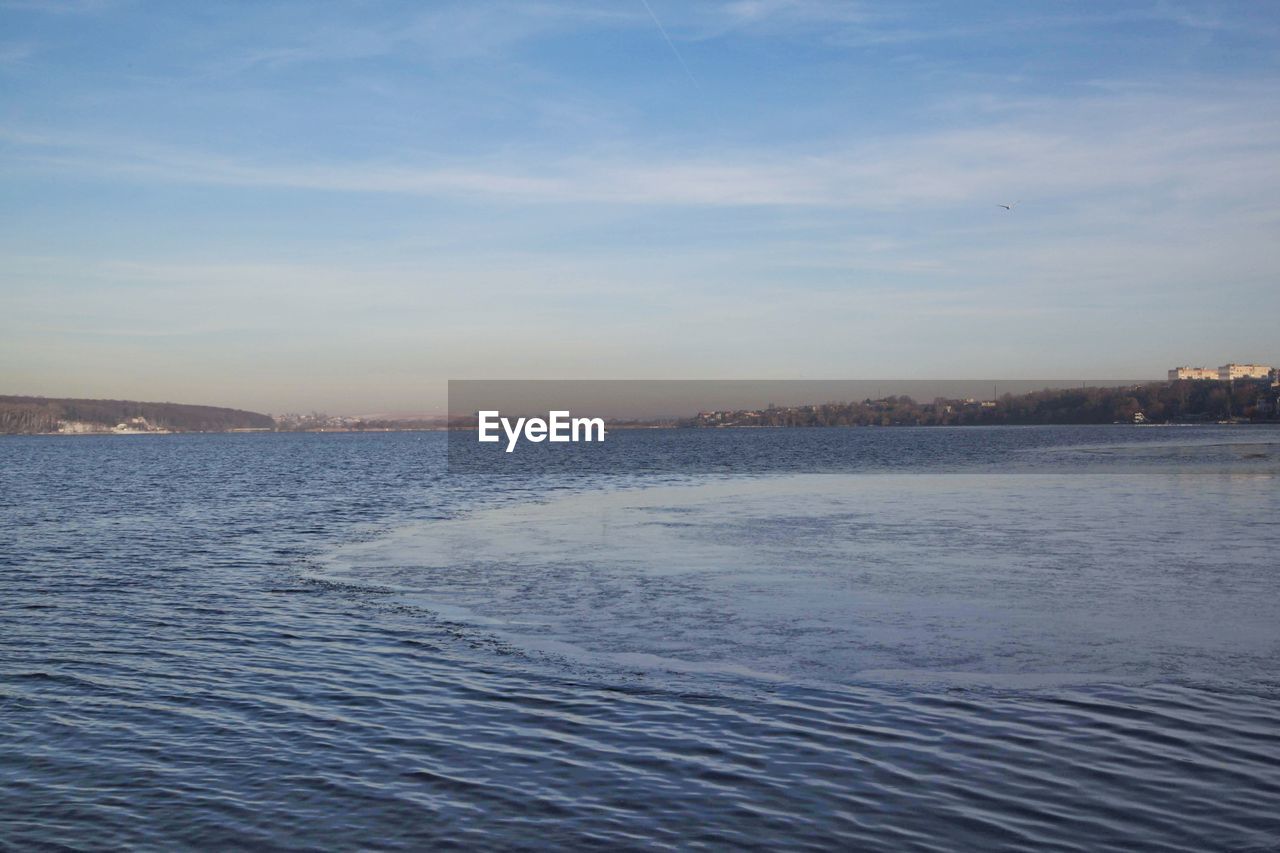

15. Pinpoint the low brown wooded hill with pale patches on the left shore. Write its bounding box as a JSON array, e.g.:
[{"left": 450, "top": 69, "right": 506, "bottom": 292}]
[{"left": 0, "top": 396, "right": 275, "bottom": 434}]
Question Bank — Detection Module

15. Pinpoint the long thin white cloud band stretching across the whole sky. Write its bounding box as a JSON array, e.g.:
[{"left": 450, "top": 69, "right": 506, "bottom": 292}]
[{"left": 0, "top": 83, "right": 1280, "bottom": 211}]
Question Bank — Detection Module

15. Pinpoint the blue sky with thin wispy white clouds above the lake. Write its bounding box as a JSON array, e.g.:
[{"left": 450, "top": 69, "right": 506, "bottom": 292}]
[{"left": 0, "top": 0, "right": 1280, "bottom": 414}]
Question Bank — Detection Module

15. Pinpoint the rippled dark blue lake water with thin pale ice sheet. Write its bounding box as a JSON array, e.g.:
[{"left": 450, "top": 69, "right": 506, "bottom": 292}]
[{"left": 0, "top": 427, "right": 1280, "bottom": 850}]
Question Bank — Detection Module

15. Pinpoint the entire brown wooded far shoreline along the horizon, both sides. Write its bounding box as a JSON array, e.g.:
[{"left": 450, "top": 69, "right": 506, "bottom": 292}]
[{"left": 0, "top": 379, "right": 1280, "bottom": 435}]
